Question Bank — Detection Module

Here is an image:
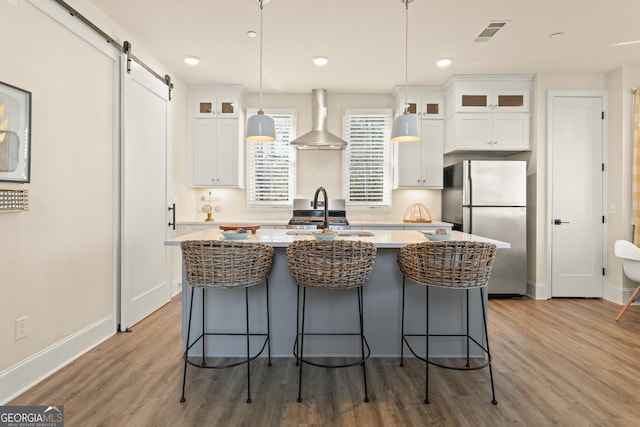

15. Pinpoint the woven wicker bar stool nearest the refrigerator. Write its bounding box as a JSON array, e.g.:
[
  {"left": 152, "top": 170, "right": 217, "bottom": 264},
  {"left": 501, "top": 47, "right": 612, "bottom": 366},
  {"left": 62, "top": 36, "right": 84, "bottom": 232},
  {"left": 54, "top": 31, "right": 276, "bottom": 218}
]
[{"left": 398, "top": 241, "right": 498, "bottom": 404}]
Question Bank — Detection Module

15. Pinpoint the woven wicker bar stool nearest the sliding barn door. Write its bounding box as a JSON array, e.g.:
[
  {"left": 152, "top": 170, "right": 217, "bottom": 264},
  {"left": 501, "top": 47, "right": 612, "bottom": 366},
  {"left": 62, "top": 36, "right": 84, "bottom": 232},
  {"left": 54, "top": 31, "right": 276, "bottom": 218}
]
[{"left": 180, "top": 240, "right": 274, "bottom": 403}]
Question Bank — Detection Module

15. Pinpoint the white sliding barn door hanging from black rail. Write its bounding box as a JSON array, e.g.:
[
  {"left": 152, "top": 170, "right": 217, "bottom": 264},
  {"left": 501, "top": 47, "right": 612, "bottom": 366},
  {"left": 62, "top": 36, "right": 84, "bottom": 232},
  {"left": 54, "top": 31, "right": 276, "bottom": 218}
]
[{"left": 120, "top": 59, "right": 171, "bottom": 330}]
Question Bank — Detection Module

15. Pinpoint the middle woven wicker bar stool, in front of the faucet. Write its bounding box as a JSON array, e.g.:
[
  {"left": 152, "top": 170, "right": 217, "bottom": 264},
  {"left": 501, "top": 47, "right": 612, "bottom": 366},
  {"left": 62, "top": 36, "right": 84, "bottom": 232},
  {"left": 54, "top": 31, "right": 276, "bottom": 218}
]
[{"left": 287, "top": 240, "right": 376, "bottom": 402}]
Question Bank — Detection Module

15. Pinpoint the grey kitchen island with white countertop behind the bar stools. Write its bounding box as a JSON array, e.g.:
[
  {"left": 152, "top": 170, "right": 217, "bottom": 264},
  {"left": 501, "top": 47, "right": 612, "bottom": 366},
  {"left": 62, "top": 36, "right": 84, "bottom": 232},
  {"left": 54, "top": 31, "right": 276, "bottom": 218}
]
[{"left": 165, "top": 229, "right": 509, "bottom": 357}]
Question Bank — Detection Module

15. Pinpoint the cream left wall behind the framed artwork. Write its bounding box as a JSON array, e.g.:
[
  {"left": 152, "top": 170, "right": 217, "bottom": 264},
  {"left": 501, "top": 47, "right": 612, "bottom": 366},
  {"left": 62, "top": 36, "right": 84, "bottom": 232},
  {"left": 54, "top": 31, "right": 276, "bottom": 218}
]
[{"left": 0, "top": 2, "right": 114, "bottom": 369}]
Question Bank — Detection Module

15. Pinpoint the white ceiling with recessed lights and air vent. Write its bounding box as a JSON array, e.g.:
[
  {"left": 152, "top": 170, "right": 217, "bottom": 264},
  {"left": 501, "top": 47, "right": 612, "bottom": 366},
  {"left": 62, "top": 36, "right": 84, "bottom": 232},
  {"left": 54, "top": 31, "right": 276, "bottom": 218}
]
[{"left": 85, "top": 0, "right": 640, "bottom": 93}]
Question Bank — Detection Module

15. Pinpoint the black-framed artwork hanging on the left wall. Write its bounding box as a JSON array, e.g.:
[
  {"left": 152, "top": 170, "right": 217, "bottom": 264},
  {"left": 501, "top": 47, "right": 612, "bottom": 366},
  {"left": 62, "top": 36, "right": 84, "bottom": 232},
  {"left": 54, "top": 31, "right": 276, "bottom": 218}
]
[{"left": 0, "top": 82, "right": 31, "bottom": 183}]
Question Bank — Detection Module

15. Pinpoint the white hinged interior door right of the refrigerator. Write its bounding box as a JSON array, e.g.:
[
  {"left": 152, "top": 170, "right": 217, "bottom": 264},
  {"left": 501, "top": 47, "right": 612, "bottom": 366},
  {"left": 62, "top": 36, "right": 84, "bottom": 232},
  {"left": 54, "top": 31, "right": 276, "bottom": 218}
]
[{"left": 548, "top": 94, "right": 605, "bottom": 298}]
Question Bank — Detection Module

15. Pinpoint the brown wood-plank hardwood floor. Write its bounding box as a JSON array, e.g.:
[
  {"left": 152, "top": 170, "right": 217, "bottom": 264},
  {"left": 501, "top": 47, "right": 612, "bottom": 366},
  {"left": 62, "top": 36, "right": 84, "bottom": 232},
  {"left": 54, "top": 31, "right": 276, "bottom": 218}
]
[{"left": 10, "top": 298, "right": 640, "bottom": 426}]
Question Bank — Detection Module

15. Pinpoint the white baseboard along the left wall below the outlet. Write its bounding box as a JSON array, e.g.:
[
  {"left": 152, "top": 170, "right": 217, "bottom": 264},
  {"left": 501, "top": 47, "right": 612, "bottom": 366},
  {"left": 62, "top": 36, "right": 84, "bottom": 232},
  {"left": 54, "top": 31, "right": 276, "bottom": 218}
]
[{"left": 0, "top": 314, "right": 117, "bottom": 405}]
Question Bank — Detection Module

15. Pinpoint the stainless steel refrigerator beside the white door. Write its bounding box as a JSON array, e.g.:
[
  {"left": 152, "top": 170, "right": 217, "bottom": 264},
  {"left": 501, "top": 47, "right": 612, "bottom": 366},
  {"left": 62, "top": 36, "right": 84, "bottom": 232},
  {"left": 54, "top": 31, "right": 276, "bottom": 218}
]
[{"left": 442, "top": 160, "right": 527, "bottom": 297}]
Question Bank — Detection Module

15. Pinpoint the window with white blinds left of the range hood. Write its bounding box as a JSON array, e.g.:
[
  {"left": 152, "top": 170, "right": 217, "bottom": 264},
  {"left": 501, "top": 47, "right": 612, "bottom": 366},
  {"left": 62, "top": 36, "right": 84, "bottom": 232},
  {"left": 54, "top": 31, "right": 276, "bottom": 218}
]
[{"left": 247, "top": 109, "right": 296, "bottom": 209}]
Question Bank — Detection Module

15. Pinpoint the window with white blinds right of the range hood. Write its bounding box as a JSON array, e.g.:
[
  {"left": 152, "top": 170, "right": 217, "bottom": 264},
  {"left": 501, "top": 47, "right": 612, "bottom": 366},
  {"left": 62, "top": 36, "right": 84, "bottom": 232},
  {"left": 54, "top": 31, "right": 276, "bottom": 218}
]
[{"left": 342, "top": 109, "right": 393, "bottom": 208}]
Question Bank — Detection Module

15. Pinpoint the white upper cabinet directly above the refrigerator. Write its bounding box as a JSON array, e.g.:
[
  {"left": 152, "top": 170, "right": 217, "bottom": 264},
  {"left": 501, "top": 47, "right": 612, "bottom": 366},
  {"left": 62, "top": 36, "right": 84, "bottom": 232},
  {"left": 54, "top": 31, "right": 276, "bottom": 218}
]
[{"left": 444, "top": 75, "right": 532, "bottom": 153}]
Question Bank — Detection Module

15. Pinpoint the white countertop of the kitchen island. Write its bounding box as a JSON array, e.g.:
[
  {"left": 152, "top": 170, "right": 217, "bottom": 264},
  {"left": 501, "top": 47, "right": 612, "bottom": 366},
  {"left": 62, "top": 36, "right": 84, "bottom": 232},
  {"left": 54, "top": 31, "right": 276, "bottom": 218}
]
[{"left": 165, "top": 228, "right": 511, "bottom": 249}]
